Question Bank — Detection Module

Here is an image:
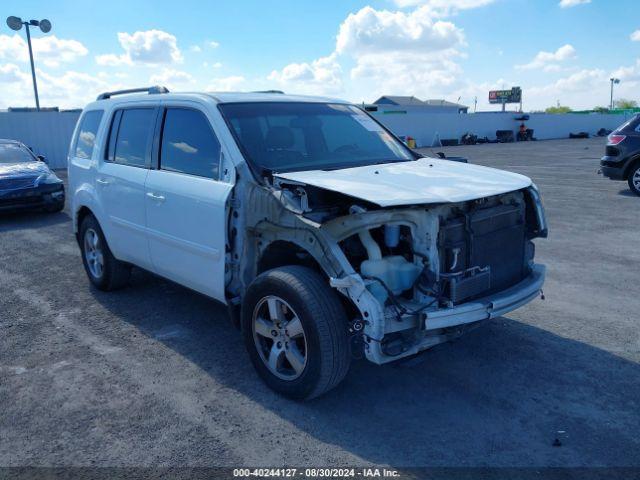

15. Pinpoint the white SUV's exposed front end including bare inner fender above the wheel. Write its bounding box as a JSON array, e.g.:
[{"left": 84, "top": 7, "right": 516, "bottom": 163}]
[{"left": 231, "top": 171, "right": 546, "bottom": 363}]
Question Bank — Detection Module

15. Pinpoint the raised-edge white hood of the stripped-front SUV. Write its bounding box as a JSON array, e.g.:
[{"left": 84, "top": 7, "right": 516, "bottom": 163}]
[{"left": 276, "top": 158, "right": 531, "bottom": 207}]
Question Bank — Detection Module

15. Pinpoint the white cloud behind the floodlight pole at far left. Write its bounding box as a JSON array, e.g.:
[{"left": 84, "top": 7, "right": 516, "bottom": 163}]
[{"left": 0, "top": 33, "right": 89, "bottom": 67}]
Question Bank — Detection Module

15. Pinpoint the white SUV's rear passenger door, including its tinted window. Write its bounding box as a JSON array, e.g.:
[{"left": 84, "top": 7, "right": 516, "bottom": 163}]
[{"left": 96, "top": 105, "right": 159, "bottom": 269}]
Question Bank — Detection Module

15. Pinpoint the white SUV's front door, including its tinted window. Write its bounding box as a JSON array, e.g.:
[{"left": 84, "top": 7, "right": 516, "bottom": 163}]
[{"left": 145, "top": 102, "right": 233, "bottom": 301}]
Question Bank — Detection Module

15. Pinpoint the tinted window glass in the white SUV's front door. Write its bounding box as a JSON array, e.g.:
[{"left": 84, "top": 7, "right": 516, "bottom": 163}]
[{"left": 160, "top": 108, "right": 220, "bottom": 180}]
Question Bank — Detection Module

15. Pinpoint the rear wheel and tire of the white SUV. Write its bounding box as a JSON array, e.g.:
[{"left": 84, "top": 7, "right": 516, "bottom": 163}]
[{"left": 79, "top": 215, "right": 131, "bottom": 291}]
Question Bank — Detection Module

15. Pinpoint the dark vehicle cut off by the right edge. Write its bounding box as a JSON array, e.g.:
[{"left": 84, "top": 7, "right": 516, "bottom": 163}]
[{"left": 600, "top": 115, "right": 640, "bottom": 196}]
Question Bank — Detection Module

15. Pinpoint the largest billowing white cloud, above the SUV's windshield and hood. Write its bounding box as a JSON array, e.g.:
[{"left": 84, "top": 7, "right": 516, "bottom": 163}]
[{"left": 268, "top": 0, "right": 476, "bottom": 99}]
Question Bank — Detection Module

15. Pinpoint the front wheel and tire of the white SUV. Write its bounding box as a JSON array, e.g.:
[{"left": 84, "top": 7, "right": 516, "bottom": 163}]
[{"left": 242, "top": 266, "right": 351, "bottom": 400}]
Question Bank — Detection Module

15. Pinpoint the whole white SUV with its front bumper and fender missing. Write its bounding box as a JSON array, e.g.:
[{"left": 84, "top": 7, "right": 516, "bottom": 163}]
[{"left": 69, "top": 87, "right": 547, "bottom": 398}]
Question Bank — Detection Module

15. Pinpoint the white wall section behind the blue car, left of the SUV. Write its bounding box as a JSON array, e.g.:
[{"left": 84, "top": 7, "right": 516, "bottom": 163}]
[{"left": 0, "top": 112, "right": 80, "bottom": 168}]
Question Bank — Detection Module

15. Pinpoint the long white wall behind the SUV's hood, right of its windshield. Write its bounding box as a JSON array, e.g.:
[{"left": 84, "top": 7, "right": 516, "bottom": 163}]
[{"left": 372, "top": 112, "right": 630, "bottom": 146}]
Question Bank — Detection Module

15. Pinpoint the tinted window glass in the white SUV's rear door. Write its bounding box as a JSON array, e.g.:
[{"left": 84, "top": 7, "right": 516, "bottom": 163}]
[{"left": 107, "top": 108, "right": 155, "bottom": 167}]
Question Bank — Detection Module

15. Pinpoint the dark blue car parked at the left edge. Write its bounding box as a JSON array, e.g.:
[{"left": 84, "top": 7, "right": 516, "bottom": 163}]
[{"left": 0, "top": 139, "right": 64, "bottom": 212}]
